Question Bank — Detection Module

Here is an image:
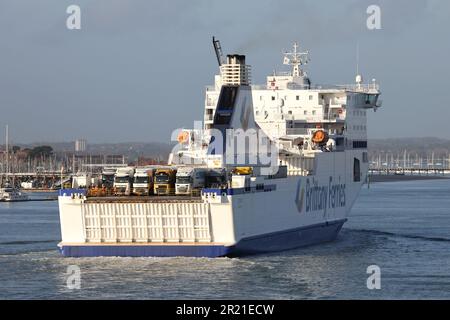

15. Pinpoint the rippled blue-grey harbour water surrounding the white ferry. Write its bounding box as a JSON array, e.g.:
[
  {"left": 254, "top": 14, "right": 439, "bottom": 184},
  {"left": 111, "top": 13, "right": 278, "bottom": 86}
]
[{"left": 0, "top": 180, "right": 450, "bottom": 299}]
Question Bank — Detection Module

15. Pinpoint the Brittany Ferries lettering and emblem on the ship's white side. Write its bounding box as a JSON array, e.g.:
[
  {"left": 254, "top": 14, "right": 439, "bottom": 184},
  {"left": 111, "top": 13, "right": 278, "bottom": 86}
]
[{"left": 295, "top": 177, "right": 345, "bottom": 213}]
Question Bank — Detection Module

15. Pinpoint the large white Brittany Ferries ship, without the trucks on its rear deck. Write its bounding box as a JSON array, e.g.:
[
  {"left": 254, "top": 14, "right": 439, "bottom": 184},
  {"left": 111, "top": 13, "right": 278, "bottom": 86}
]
[{"left": 58, "top": 38, "right": 381, "bottom": 257}]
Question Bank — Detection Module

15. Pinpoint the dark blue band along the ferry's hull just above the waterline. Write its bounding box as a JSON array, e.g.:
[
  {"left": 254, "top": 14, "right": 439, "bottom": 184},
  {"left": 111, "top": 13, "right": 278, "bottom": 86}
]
[{"left": 60, "top": 219, "right": 347, "bottom": 258}]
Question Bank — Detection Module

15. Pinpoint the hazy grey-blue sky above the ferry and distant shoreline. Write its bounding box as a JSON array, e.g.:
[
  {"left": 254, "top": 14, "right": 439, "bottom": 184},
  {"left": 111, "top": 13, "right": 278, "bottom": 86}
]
[{"left": 0, "top": 0, "right": 450, "bottom": 143}]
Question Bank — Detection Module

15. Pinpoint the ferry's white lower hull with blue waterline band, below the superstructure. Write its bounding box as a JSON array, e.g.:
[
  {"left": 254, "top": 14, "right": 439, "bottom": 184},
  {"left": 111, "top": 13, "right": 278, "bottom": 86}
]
[{"left": 59, "top": 151, "right": 366, "bottom": 257}]
